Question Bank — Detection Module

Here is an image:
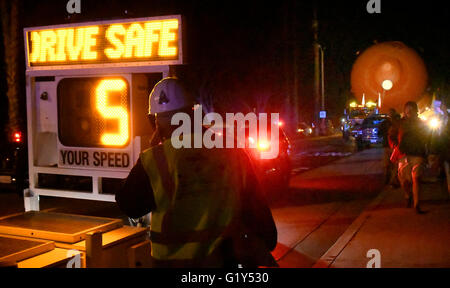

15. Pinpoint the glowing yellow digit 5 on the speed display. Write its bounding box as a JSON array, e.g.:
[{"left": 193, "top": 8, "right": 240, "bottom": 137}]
[{"left": 96, "top": 79, "right": 129, "bottom": 146}]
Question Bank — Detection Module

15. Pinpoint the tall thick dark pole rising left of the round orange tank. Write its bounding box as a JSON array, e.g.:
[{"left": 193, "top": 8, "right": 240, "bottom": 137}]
[{"left": 312, "top": 1, "right": 321, "bottom": 136}]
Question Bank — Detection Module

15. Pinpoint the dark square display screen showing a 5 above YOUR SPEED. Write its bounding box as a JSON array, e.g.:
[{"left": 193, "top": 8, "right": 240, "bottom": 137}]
[{"left": 58, "top": 77, "right": 130, "bottom": 147}]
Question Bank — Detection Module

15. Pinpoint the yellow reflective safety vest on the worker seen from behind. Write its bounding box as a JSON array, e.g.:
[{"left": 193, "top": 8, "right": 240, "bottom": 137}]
[{"left": 140, "top": 139, "right": 245, "bottom": 261}]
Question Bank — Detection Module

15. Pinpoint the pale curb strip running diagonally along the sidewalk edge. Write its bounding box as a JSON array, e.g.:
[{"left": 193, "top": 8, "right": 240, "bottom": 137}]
[{"left": 312, "top": 186, "right": 392, "bottom": 268}]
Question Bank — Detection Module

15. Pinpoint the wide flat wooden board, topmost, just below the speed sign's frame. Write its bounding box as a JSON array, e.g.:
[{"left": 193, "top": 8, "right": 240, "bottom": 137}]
[{"left": 0, "top": 211, "right": 123, "bottom": 243}]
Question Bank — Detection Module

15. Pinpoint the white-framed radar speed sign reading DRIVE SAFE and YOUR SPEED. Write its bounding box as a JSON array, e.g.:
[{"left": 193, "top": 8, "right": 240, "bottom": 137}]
[{"left": 24, "top": 15, "right": 183, "bottom": 211}]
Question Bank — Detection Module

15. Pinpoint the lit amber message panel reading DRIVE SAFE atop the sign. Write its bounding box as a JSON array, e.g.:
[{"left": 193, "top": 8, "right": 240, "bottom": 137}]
[{"left": 27, "top": 19, "right": 180, "bottom": 65}]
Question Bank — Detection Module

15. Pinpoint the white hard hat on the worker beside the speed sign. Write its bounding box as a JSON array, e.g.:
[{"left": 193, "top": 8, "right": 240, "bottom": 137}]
[{"left": 148, "top": 77, "right": 194, "bottom": 115}]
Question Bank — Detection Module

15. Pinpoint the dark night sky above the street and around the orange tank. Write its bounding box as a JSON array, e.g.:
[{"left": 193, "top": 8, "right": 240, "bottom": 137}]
[{"left": 0, "top": 0, "right": 450, "bottom": 133}]
